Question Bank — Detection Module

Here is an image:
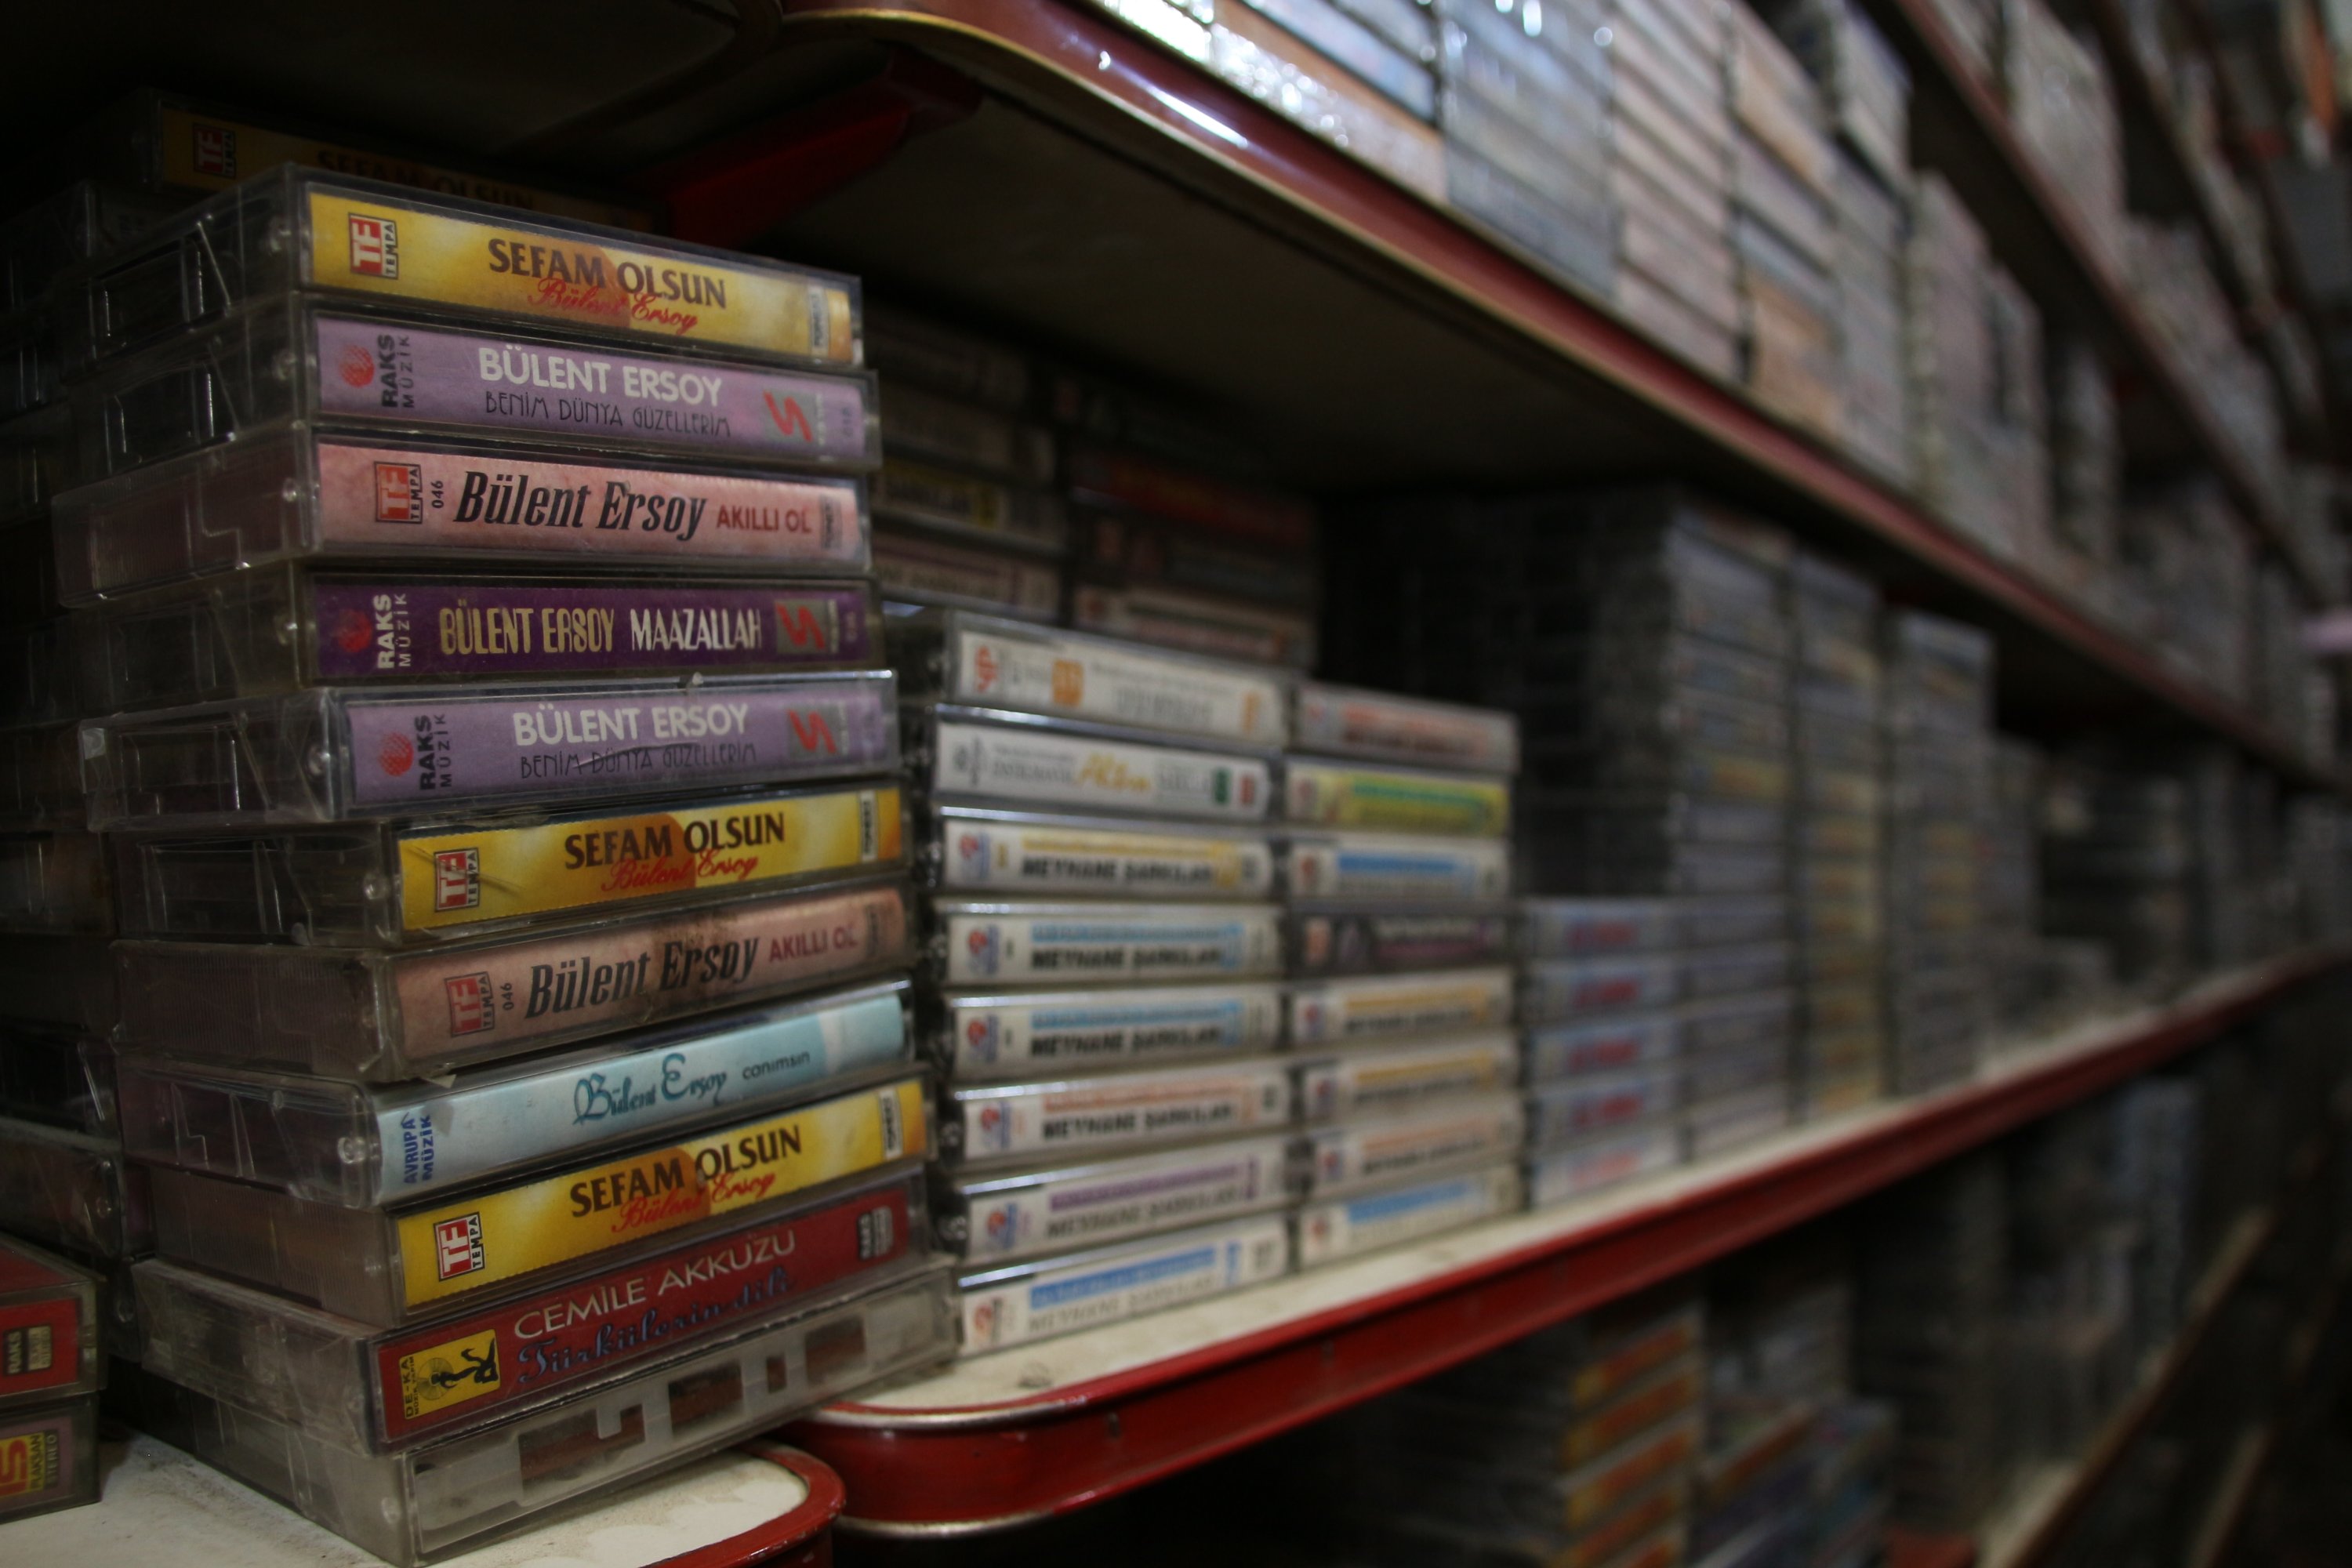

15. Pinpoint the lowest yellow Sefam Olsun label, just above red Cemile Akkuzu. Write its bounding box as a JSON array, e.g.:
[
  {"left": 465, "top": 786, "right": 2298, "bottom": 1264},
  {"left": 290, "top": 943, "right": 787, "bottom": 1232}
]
[{"left": 397, "top": 1079, "right": 929, "bottom": 1316}]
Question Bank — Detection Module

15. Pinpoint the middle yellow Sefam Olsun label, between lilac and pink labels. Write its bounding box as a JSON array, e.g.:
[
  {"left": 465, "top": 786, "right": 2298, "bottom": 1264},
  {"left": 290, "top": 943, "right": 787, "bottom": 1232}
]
[{"left": 400, "top": 787, "right": 903, "bottom": 931}]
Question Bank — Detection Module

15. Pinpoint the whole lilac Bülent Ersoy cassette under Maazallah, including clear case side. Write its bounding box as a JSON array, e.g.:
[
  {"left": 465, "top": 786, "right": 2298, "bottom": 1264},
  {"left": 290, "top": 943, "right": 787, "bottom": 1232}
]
[{"left": 82, "top": 670, "right": 898, "bottom": 827}]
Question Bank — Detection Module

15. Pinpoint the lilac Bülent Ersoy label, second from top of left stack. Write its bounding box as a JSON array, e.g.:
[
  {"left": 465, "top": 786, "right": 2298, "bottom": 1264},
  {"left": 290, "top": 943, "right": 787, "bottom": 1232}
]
[{"left": 318, "top": 315, "right": 870, "bottom": 461}]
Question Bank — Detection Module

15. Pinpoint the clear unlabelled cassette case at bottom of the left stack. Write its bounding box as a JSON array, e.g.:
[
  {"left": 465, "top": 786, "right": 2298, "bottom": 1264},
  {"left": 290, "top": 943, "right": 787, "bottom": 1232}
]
[{"left": 133, "top": 1274, "right": 955, "bottom": 1568}]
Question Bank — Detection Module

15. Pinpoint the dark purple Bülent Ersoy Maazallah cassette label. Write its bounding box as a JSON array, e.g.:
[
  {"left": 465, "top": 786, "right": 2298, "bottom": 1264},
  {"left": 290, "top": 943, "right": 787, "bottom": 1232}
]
[{"left": 310, "top": 581, "right": 873, "bottom": 682}]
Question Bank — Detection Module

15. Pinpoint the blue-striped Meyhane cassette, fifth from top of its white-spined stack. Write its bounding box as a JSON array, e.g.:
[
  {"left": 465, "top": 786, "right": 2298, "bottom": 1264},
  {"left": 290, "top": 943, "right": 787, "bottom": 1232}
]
[{"left": 931, "top": 980, "right": 1282, "bottom": 1081}]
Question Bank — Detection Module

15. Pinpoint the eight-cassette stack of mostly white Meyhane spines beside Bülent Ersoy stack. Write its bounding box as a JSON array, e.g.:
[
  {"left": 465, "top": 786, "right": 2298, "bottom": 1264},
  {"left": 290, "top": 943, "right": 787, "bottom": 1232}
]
[{"left": 889, "top": 609, "right": 1294, "bottom": 1354}]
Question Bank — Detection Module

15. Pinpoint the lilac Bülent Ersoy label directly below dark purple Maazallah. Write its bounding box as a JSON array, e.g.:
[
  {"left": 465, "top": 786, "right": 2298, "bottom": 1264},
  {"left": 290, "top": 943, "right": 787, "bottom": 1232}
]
[{"left": 343, "top": 677, "right": 898, "bottom": 806}]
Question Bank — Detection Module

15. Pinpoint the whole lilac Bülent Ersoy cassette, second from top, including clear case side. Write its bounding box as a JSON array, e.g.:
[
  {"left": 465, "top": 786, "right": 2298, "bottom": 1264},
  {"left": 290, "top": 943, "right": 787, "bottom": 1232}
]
[{"left": 73, "top": 301, "right": 880, "bottom": 480}]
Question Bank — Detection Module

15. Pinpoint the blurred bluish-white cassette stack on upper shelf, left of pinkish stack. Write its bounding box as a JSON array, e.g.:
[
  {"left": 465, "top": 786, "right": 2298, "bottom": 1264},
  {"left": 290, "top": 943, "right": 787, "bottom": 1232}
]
[{"left": 1435, "top": 0, "right": 1616, "bottom": 296}]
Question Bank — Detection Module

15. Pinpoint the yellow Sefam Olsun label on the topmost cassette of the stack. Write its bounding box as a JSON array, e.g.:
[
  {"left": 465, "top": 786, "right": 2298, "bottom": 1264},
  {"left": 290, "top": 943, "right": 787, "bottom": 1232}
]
[{"left": 310, "top": 191, "right": 856, "bottom": 365}]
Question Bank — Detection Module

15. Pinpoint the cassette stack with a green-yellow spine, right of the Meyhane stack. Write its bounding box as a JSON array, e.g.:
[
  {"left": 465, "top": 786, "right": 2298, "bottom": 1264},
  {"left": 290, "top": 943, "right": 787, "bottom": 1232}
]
[{"left": 1282, "top": 682, "right": 1555, "bottom": 1267}]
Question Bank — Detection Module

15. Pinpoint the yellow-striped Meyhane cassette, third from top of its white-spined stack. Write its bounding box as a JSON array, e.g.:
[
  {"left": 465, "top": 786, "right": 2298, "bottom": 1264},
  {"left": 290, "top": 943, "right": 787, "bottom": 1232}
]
[{"left": 917, "top": 806, "right": 1275, "bottom": 900}]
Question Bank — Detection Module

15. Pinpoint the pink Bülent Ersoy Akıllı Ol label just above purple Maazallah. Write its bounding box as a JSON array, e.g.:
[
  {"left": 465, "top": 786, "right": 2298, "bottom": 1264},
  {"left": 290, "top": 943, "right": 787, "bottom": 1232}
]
[{"left": 318, "top": 442, "right": 868, "bottom": 569}]
